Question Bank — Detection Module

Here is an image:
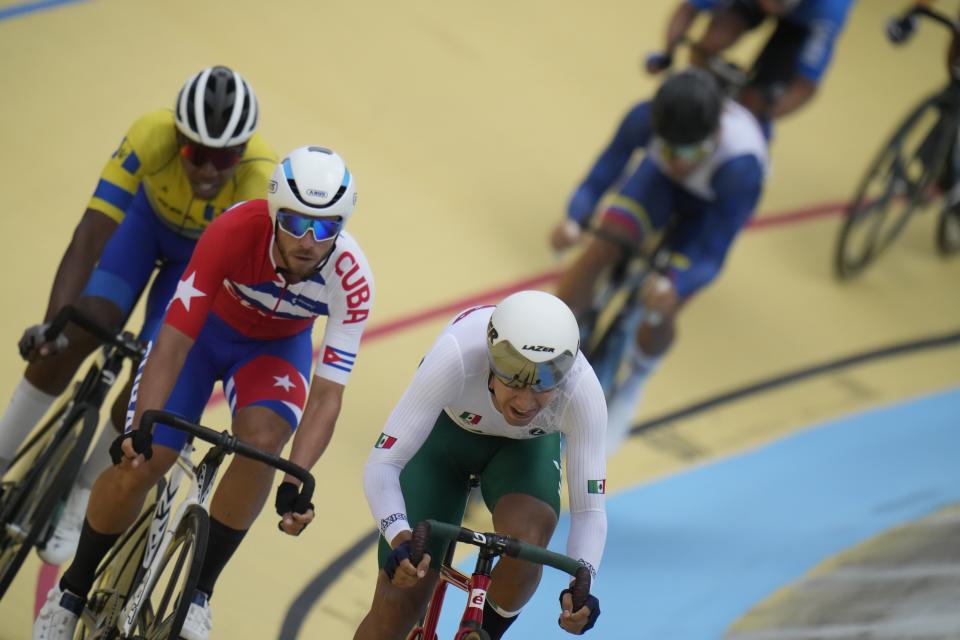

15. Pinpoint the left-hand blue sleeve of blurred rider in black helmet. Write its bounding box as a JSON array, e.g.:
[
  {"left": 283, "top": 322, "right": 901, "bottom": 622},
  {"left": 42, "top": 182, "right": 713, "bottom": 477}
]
[{"left": 567, "top": 102, "right": 652, "bottom": 226}]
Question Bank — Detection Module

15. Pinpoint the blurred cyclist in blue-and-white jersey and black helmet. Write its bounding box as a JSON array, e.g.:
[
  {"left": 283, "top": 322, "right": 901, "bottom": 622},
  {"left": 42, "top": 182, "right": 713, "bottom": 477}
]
[{"left": 552, "top": 67, "right": 767, "bottom": 455}]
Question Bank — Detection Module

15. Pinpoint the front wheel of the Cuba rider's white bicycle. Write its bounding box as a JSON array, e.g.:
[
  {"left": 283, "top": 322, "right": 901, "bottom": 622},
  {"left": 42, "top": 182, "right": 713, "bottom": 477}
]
[{"left": 127, "top": 505, "right": 210, "bottom": 640}]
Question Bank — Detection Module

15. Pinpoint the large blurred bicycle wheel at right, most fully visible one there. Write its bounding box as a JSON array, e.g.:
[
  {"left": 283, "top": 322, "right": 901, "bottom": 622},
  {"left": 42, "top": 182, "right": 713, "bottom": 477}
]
[{"left": 834, "top": 93, "right": 956, "bottom": 279}]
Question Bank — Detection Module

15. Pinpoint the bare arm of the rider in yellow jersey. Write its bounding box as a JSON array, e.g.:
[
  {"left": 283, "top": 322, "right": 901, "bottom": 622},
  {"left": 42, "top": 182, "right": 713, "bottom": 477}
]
[{"left": 44, "top": 209, "right": 117, "bottom": 322}]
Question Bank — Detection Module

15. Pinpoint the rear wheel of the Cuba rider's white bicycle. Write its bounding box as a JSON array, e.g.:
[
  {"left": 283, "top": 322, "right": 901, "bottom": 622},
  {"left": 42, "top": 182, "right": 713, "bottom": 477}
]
[{"left": 74, "top": 501, "right": 156, "bottom": 640}]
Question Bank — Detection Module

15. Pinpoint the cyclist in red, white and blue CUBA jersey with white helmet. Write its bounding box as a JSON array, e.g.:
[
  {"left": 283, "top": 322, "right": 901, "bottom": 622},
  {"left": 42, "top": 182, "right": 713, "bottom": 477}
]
[{"left": 34, "top": 147, "right": 374, "bottom": 640}]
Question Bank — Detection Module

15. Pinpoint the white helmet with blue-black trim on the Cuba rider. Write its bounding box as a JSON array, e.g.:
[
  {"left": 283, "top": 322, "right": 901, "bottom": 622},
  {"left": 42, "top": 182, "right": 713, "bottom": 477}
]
[{"left": 267, "top": 147, "right": 357, "bottom": 223}]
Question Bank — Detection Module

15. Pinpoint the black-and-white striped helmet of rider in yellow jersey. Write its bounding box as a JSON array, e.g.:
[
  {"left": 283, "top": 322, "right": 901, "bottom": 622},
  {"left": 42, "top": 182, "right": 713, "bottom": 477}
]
[{"left": 173, "top": 66, "right": 259, "bottom": 149}]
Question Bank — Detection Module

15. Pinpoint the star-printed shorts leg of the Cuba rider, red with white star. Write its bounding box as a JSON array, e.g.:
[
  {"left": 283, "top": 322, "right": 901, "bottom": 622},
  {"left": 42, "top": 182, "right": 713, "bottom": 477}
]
[{"left": 221, "top": 328, "right": 313, "bottom": 431}]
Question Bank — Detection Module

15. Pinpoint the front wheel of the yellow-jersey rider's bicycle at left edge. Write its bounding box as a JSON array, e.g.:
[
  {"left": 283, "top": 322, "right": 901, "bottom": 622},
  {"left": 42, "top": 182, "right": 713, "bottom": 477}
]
[{"left": 0, "top": 407, "right": 97, "bottom": 598}]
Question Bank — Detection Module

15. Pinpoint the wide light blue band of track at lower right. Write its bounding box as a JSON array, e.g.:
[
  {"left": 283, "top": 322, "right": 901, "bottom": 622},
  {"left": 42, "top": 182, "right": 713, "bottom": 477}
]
[{"left": 470, "top": 388, "right": 960, "bottom": 640}]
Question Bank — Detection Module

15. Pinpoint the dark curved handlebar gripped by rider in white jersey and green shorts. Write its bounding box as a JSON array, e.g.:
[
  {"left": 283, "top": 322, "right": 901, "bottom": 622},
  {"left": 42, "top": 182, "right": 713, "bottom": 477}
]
[{"left": 410, "top": 520, "right": 590, "bottom": 611}]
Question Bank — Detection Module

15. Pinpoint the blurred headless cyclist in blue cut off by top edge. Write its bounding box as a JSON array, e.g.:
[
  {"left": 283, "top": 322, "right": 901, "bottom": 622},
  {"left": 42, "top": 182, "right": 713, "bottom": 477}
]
[{"left": 647, "top": 0, "right": 853, "bottom": 133}]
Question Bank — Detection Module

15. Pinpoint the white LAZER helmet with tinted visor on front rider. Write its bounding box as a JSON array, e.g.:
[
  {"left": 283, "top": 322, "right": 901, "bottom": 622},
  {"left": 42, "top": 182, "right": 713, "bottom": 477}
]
[{"left": 487, "top": 291, "right": 580, "bottom": 393}]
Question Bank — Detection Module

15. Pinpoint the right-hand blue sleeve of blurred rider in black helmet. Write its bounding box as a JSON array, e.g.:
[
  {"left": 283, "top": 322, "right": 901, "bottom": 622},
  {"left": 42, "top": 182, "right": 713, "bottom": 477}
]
[{"left": 672, "top": 155, "right": 763, "bottom": 298}]
